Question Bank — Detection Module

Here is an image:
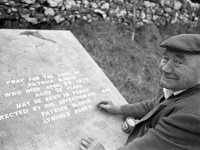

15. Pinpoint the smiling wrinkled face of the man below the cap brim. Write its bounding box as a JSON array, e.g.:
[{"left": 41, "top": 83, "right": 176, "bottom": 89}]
[{"left": 160, "top": 50, "right": 200, "bottom": 91}]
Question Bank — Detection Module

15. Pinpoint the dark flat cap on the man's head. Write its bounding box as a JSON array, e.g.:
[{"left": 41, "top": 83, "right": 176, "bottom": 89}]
[{"left": 160, "top": 34, "right": 200, "bottom": 54}]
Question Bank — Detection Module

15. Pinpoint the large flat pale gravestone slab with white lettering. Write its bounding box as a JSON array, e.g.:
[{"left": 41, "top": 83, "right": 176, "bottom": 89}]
[{"left": 0, "top": 29, "right": 127, "bottom": 150}]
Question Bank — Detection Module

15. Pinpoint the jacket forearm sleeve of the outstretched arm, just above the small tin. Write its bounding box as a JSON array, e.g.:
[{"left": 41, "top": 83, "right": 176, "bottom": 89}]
[{"left": 121, "top": 100, "right": 154, "bottom": 119}]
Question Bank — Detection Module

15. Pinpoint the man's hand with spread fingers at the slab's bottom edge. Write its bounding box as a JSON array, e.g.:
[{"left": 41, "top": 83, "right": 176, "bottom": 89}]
[{"left": 80, "top": 137, "right": 105, "bottom": 150}]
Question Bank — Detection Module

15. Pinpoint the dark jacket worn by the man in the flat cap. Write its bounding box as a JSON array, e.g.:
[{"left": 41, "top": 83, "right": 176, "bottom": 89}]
[{"left": 117, "top": 85, "right": 200, "bottom": 150}]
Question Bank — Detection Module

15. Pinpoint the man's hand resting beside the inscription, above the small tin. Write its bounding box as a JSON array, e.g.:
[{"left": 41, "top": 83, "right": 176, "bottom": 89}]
[{"left": 97, "top": 101, "right": 121, "bottom": 115}]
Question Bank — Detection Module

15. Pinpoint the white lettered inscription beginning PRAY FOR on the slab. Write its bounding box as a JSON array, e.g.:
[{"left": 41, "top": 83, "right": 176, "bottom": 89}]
[{"left": 0, "top": 71, "right": 110, "bottom": 124}]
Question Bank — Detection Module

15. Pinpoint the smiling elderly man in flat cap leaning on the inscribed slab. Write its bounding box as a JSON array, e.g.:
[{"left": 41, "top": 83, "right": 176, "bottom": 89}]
[{"left": 80, "top": 34, "right": 200, "bottom": 150}]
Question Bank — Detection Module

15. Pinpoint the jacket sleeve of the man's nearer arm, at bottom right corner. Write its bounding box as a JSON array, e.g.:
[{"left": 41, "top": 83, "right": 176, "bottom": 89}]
[{"left": 115, "top": 108, "right": 200, "bottom": 150}]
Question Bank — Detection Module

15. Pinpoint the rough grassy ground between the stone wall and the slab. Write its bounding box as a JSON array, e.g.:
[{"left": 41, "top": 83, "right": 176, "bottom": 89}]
[{"left": 1, "top": 21, "right": 200, "bottom": 103}]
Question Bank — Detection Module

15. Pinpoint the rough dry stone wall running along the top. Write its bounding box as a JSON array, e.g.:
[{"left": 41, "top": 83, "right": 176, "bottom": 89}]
[{"left": 0, "top": 0, "right": 200, "bottom": 28}]
